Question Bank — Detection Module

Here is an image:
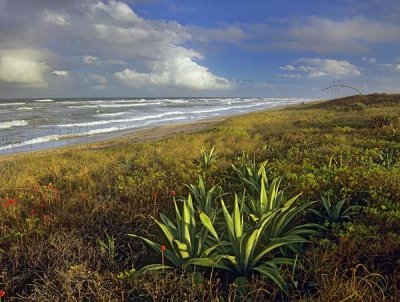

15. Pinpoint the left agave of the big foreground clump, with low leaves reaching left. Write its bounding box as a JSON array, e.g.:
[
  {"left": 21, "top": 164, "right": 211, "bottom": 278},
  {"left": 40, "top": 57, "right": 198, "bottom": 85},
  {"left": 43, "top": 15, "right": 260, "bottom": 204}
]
[{"left": 128, "top": 195, "right": 216, "bottom": 276}]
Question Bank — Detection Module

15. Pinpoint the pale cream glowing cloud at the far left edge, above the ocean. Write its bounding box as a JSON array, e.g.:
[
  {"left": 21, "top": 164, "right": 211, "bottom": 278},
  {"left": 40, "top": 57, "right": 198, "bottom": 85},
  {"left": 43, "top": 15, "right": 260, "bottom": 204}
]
[{"left": 0, "top": 49, "right": 48, "bottom": 87}]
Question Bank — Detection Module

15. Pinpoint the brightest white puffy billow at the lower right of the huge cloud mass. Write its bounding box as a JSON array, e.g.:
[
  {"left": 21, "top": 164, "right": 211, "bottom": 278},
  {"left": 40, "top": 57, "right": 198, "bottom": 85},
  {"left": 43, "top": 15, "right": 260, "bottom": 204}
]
[{"left": 114, "top": 57, "right": 231, "bottom": 89}]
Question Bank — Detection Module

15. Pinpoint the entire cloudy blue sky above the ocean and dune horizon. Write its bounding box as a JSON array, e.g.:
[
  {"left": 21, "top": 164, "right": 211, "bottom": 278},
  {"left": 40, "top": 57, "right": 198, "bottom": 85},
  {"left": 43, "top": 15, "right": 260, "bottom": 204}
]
[{"left": 0, "top": 0, "right": 400, "bottom": 98}]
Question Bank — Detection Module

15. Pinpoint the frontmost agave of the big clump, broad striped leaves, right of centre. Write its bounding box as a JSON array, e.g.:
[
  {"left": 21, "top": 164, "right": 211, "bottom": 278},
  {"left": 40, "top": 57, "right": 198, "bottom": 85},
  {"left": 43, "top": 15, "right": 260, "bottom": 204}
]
[{"left": 188, "top": 196, "right": 304, "bottom": 291}]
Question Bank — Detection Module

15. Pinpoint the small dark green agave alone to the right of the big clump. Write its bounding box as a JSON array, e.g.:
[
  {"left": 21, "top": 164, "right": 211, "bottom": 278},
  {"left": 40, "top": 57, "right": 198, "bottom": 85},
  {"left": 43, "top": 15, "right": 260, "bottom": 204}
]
[{"left": 310, "top": 195, "right": 358, "bottom": 222}]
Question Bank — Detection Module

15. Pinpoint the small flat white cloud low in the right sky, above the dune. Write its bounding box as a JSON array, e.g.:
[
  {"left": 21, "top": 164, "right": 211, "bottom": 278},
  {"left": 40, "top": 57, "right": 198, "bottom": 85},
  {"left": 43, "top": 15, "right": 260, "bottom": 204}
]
[{"left": 282, "top": 58, "right": 361, "bottom": 78}]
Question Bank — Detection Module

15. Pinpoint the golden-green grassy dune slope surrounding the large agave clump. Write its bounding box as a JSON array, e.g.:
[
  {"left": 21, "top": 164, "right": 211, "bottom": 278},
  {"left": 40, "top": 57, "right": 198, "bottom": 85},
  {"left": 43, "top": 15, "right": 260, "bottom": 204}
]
[{"left": 0, "top": 95, "right": 400, "bottom": 301}]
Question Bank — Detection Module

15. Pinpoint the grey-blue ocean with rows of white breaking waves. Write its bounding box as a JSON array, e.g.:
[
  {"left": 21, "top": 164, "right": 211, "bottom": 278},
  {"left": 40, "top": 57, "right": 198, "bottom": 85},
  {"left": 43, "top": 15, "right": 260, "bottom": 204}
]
[{"left": 0, "top": 98, "right": 309, "bottom": 154}]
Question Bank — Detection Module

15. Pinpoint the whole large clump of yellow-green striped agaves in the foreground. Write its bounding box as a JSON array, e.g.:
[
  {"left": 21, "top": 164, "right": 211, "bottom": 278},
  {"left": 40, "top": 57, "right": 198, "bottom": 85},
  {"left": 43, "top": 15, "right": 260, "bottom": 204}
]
[{"left": 126, "top": 160, "right": 317, "bottom": 291}]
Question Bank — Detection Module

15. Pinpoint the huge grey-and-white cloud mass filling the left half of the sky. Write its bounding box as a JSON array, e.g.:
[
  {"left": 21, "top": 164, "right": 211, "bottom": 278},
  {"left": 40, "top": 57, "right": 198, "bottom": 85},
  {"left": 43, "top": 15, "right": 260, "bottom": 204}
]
[{"left": 0, "top": 0, "right": 231, "bottom": 90}]
